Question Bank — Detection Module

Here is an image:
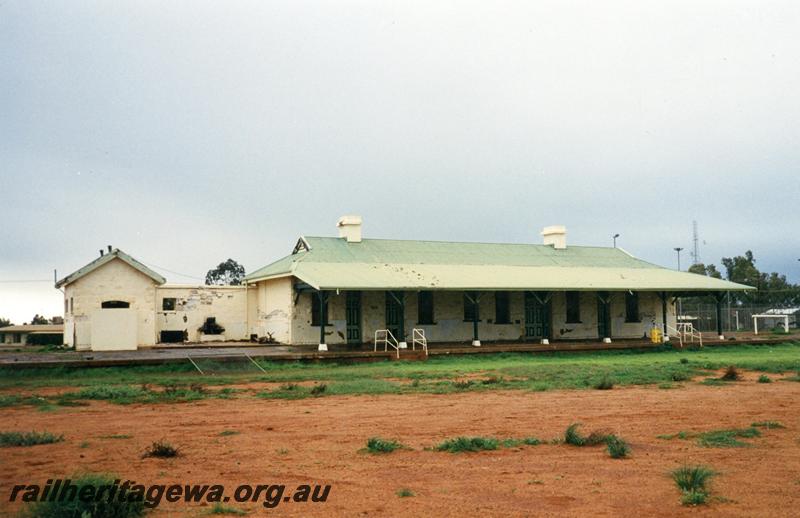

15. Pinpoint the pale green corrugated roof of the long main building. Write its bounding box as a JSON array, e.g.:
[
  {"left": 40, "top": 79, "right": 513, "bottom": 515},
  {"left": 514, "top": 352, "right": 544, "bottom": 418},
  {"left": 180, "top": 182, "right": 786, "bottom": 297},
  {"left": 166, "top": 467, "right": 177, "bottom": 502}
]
[{"left": 247, "top": 237, "right": 751, "bottom": 291}]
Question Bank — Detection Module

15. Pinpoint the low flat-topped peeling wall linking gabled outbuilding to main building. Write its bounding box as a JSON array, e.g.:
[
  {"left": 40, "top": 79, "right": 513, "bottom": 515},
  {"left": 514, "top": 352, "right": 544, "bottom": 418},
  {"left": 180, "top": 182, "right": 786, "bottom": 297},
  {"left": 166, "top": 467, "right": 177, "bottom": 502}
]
[{"left": 155, "top": 285, "right": 248, "bottom": 342}]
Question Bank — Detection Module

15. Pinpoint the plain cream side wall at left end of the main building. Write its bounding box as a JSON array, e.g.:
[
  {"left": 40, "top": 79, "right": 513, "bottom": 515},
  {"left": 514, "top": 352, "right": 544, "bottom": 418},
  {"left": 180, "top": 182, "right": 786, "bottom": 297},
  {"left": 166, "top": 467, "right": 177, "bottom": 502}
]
[{"left": 250, "top": 277, "right": 294, "bottom": 343}]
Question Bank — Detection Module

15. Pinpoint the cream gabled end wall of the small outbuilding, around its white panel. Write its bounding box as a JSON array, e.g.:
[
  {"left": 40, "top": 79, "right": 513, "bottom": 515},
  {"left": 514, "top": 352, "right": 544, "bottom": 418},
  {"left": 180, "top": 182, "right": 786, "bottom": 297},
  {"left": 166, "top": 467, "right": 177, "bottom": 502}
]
[{"left": 64, "top": 259, "right": 156, "bottom": 350}]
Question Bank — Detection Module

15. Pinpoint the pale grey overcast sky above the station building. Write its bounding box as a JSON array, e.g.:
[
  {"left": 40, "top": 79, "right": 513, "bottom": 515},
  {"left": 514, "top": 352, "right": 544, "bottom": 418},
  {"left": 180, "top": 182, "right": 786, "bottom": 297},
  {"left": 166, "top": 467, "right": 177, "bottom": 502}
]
[{"left": 0, "top": 0, "right": 800, "bottom": 323}]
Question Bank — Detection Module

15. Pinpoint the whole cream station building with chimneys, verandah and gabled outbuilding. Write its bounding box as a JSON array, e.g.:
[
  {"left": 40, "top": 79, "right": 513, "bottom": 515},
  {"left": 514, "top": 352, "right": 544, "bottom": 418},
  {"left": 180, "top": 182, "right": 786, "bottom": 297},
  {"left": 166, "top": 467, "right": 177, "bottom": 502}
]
[{"left": 56, "top": 216, "right": 750, "bottom": 350}]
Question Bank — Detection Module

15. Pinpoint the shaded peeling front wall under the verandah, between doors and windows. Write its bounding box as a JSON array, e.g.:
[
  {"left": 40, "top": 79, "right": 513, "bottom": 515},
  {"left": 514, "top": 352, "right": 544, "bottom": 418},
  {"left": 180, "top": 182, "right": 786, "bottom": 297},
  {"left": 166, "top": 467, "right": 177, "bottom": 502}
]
[{"left": 292, "top": 291, "right": 675, "bottom": 344}]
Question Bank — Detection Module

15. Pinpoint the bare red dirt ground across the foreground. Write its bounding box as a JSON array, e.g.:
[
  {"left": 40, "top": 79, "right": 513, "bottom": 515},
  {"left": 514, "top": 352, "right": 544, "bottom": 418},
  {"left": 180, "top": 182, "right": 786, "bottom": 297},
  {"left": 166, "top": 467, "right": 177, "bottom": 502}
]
[{"left": 0, "top": 375, "right": 800, "bottom": 517}]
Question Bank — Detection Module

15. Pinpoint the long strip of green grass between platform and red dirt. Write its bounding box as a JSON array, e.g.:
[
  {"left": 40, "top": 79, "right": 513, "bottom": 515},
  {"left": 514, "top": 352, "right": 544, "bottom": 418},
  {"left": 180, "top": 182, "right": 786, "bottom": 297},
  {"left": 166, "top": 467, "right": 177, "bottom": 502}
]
[{"left": 0, "top": 342, "right": 800, "bottom": 408}]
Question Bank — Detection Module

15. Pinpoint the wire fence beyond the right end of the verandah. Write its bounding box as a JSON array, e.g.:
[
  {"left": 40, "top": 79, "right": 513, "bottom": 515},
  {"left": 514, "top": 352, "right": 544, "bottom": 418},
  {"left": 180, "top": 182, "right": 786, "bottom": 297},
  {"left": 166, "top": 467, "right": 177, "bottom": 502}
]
[{"left": 679, "top": 301, "right": 800, "bottom": 332}]
